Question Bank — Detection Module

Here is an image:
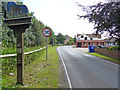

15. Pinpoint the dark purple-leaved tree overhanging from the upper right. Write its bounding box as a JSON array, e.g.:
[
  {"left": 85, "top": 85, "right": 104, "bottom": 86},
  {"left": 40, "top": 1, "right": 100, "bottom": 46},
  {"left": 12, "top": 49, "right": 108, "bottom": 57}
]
[{"left": 78, "top": 2, "right": 120, "bottom": 45}]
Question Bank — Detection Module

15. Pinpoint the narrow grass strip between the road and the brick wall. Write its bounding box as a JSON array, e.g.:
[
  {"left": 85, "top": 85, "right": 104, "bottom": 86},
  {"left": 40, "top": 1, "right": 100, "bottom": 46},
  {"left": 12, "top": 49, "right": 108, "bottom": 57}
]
[{"left": 88, "top": 53, "right": 120, "bottom": 64}]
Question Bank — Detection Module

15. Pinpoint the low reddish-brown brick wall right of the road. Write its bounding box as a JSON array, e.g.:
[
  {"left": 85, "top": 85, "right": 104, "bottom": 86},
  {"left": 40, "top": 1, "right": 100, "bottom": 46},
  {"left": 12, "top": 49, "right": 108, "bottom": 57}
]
[{"left": 95, "top": 48, "right": 120, "bottom": 60}]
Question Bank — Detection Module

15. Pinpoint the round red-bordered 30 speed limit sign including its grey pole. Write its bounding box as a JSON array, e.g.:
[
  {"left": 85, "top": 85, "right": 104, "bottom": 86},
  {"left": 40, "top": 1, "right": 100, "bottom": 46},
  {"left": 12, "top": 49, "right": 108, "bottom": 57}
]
[{"left": 43, "top": 28, "right": 51, "bottom": 60}]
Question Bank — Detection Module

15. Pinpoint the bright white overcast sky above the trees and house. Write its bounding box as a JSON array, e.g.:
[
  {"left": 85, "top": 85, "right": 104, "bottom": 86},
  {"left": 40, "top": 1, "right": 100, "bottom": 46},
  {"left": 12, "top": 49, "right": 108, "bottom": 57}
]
[{"left": 22, "top": 0, "right": 104, "bottom": 37}]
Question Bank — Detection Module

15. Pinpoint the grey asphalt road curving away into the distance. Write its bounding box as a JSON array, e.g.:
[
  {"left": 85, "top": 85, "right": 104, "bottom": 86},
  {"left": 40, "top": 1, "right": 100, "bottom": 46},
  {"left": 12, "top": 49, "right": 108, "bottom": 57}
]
[{"left": 57, "top": 46, "right": 118, "bottom": 88}]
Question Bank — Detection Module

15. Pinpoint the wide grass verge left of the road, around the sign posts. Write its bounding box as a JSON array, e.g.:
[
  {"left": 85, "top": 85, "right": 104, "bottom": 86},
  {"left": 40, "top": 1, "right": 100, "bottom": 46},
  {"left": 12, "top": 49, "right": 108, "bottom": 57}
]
[{"left": 2, "top": 46, "right": 59, "bottom": 89}]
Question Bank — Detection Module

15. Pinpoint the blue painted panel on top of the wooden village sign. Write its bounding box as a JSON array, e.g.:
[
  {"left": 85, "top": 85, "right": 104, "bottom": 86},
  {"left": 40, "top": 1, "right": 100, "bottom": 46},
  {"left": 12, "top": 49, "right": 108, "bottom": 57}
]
[{"left": 6, "top": 2, "right": 28, "bottom": 19}]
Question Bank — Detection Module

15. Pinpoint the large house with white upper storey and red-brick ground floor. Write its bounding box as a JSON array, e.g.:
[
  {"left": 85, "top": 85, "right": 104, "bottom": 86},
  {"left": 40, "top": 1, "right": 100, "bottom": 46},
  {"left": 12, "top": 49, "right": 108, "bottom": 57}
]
[{"left": 76, "top": 34, "right": 105, "bottom": 48}]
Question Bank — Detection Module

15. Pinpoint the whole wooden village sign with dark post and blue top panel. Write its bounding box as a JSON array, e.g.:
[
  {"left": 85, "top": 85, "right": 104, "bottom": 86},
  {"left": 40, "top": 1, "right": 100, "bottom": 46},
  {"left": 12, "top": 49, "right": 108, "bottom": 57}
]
[{"left": 4, "top": 2, "right": 31, "bottom": 85}]
